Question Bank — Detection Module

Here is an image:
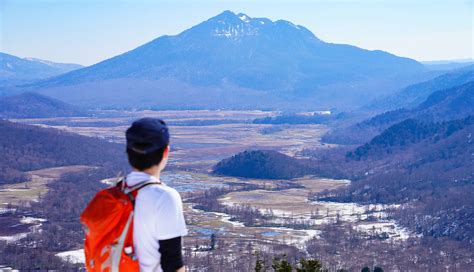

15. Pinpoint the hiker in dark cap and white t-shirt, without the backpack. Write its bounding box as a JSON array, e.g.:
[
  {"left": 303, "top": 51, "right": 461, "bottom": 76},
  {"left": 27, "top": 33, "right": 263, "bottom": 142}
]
[{"left": 125, "top": 118, "right": 187, "bottom": 272}]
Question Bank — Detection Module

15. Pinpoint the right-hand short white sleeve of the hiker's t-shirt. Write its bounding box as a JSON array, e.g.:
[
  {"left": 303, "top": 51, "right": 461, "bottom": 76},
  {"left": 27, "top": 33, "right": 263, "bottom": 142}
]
[{"left": 155, "top": 189, "right": 188, "bottom": 240}]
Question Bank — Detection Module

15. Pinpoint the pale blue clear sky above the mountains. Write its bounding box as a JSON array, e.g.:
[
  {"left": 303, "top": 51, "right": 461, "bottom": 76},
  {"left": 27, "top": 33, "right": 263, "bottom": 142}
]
[{"left": 0, "top": 0, "right": 474, "bottom": 65}]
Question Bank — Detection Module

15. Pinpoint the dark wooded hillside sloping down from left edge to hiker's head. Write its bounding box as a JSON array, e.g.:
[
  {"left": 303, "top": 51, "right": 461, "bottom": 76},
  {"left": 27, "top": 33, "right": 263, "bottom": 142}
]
[{"left": 0, "top": 120, "right": 126, "bottom": 184}]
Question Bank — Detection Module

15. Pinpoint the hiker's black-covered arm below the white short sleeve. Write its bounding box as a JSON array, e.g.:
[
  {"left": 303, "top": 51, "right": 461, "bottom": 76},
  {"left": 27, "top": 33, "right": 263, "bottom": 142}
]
[{"left": 159, "top": 236, "right": 184, "bottom": 272}]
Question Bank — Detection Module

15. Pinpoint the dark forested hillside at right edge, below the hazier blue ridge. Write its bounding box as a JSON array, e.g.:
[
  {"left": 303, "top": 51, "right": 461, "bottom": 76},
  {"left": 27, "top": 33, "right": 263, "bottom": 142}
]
[{"left": 317, "top": 116, "right": 474, "bottom": 243}]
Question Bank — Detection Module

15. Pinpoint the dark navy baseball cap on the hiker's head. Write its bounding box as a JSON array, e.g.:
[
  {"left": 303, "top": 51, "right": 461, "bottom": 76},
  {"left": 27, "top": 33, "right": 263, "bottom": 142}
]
[{"left": 125, "top": 117, "right": 170, "bottom": 154}]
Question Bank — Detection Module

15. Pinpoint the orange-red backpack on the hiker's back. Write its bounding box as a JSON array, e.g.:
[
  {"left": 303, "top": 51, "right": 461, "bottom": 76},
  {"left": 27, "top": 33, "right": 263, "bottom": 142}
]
[{"left": 81, "top": 180, "right": 160, "bottom": 272}]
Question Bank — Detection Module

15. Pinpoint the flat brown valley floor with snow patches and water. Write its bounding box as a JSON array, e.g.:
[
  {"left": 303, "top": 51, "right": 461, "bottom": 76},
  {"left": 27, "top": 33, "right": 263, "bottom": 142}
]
[{"left": 0, "top": 111, "right": 470, "bottom": 270}]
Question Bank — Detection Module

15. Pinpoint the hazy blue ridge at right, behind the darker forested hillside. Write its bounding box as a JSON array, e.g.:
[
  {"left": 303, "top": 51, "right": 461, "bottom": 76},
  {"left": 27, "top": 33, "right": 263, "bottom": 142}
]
[{"left": 323, "top": 68, "right": 474, "bottom": 144}]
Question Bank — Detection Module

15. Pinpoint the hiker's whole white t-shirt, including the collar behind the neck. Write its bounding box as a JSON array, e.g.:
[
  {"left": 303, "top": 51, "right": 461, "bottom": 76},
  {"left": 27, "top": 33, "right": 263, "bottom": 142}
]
[{"left": 126, "top": 172, "right": 188, "bottom": 272}]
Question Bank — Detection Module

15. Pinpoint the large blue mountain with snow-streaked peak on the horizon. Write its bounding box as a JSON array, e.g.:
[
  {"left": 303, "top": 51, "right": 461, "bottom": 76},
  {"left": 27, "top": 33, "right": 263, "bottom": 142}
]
[{"left": 14, "top": 11, "right": 424, "bottom": 108}]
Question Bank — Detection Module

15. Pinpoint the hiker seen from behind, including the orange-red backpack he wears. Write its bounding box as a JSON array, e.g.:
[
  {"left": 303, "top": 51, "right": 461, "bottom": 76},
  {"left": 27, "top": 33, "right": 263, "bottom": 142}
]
[{"left": 81, "top": 118, "right": 187, "bottom": 272}]
